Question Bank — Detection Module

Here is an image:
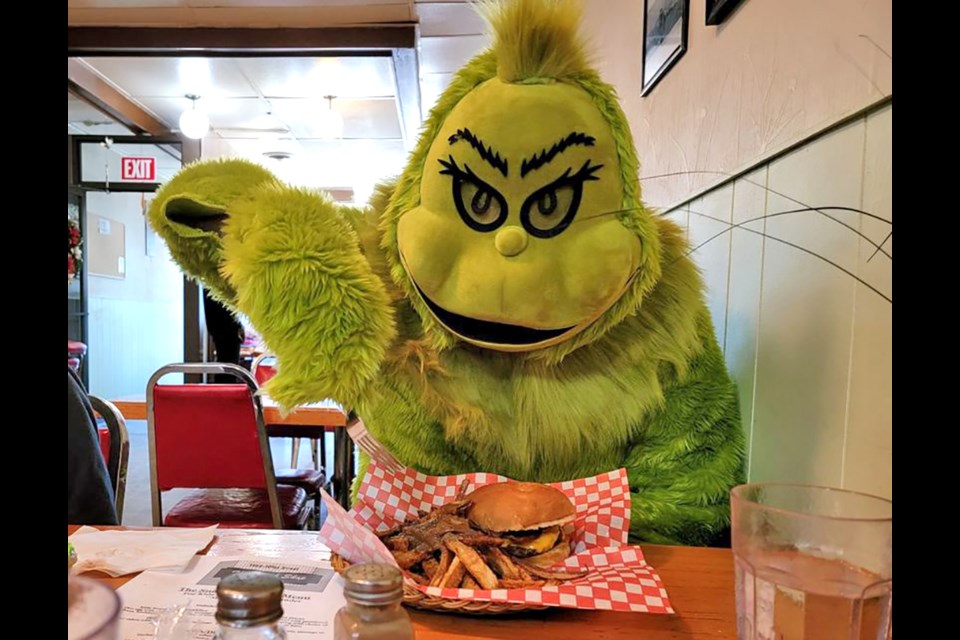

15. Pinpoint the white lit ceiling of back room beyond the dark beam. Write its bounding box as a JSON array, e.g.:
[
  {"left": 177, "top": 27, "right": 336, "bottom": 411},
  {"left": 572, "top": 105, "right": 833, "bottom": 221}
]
[{"left": 81, "top": 57, "right": 403, "bottom": 140}]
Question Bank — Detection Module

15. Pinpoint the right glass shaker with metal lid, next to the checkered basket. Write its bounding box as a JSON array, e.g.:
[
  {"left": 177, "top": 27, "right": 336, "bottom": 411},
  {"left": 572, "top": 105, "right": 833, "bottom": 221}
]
[{"left": 334, "top": 564, "right": 413, "bottom": 640}]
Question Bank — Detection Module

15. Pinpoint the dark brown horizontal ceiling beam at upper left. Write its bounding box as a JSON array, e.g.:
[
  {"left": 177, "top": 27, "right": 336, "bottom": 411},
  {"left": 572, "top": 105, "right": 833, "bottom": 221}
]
[{"left": 67, "top": 24, "right": 416, "bottom": 57}]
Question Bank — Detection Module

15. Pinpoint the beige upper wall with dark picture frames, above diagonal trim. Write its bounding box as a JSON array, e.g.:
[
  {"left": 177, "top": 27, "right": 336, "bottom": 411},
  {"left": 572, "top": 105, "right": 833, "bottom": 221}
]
[{"left": 585, "top": 0, "right": 893, "bottom": 209}]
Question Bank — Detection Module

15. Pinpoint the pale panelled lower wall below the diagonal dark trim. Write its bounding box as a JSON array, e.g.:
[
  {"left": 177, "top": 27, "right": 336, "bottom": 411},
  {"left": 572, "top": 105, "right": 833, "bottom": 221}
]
[{"left": 667, "top": 105, "right": 893, "bottom": 496}]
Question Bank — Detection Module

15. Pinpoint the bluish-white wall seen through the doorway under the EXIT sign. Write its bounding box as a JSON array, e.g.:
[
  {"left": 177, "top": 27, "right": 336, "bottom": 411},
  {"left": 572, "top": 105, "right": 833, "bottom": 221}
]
[{"left": 84, "top": 192, "right": 183, "bottom": 399}]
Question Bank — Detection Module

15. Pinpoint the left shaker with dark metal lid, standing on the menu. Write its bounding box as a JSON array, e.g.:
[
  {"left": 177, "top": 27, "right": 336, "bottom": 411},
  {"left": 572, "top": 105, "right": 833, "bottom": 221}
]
[{"left": 216, "top": 571, "right": 287, "bottom": 640}]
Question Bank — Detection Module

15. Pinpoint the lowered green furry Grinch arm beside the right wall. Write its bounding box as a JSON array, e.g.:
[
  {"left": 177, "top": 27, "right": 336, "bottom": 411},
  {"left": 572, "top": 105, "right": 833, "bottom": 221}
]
[{"left": 625, "top": 319, "right": 745, "bottom": 545}]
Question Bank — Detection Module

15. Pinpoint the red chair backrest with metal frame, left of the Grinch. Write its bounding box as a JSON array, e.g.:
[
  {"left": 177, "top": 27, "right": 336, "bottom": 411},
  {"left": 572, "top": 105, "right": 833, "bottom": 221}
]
[{"left": 147, "top": 363, "right": 282, "bottom": 529}]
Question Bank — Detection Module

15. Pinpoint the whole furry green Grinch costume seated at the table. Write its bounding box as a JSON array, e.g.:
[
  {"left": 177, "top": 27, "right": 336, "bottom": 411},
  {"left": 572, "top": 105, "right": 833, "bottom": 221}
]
[{"left": 150, "top": 0, "right": 744, "bottom": 544}]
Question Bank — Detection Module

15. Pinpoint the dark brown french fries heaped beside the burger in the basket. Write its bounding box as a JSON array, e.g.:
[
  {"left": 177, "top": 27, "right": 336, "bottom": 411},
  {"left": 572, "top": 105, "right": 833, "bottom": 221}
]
[{"left": 377, "top": 496, "right": 586, "bottom": 589}]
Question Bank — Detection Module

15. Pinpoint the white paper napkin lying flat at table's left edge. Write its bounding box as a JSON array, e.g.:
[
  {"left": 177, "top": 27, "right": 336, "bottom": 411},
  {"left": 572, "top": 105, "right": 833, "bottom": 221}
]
[{"left": 70, "top": 525, "right": 217, "bottom": 576}]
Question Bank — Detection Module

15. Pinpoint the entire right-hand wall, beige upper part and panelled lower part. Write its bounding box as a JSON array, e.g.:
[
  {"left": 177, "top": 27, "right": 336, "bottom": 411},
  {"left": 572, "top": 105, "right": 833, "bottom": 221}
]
[{"left": 568, "top": 0, "right": 893, "bottom": 496}]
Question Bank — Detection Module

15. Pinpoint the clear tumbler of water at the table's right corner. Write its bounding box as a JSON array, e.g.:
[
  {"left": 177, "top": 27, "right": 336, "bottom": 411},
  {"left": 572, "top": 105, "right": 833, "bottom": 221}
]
[{"left": 730, "top": 484, "right": 893, "bottom": 640}]
